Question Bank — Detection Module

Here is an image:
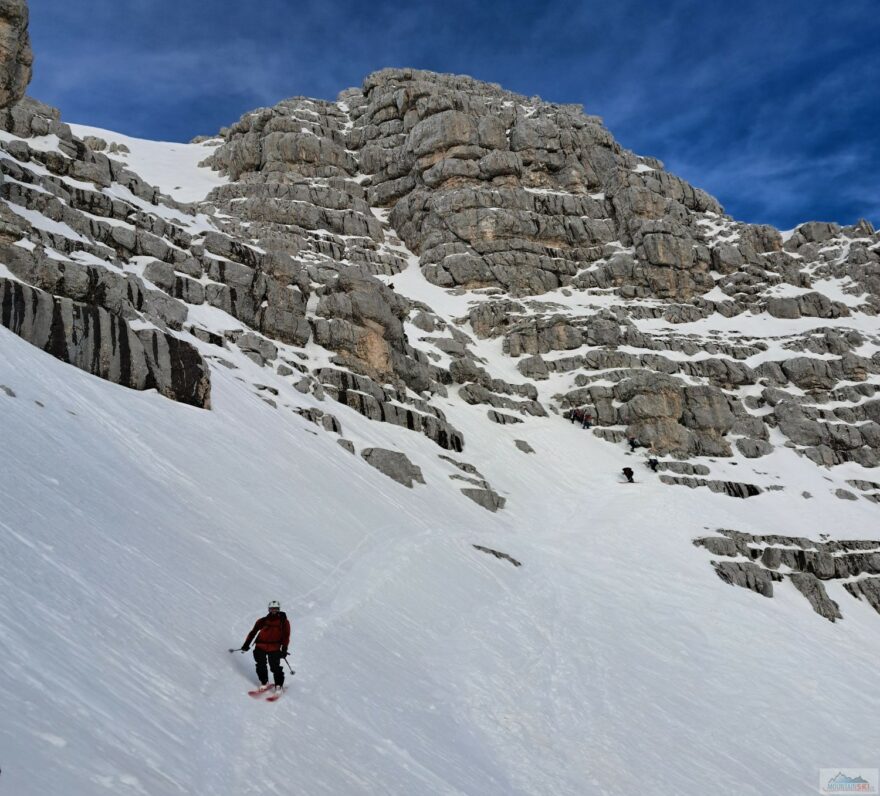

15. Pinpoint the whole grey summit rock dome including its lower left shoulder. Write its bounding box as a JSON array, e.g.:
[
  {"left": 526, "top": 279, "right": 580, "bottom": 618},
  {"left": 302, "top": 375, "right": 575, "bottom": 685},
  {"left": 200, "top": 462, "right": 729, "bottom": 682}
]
[{"left": 206, "top": 63, "right": 720, "bottom": 299}]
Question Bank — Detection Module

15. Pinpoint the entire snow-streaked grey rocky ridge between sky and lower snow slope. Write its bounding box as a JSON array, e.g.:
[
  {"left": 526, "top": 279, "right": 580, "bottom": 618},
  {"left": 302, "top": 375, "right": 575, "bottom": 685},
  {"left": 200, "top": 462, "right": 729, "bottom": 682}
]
[{"left": 0, "top": 23, "right": 880, "bottom": 548}]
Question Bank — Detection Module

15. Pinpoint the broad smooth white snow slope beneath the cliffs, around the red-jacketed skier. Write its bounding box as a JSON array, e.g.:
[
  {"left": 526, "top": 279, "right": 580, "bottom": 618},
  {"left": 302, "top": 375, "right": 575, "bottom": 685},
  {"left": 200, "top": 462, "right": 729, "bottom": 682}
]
[{"left": 0, "top": 308, "right": 880, "bottom": 796}]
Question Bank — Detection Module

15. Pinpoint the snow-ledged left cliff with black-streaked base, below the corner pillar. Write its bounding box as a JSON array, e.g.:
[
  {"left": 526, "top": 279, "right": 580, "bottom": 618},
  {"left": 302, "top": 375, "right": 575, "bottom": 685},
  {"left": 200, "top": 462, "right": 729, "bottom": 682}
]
[{"left": 0, "top": 71, "right": 211, "bottom": 408}]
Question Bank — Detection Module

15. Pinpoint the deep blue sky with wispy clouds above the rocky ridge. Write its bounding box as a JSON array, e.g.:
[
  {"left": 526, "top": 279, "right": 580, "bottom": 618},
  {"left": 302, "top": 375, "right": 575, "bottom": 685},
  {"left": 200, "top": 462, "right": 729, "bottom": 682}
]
[{"left": 29, "top": 0, "right": 880, "bottom": 228}]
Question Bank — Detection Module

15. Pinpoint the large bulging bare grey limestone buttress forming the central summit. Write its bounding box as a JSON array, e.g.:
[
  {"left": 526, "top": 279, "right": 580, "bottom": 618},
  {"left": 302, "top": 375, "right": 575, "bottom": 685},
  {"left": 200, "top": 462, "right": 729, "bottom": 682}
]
[{"left": 334, "top": 69, "right": 721, "bottom": 297}]
